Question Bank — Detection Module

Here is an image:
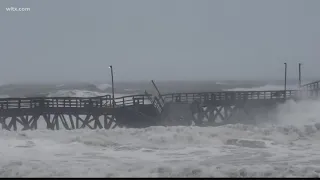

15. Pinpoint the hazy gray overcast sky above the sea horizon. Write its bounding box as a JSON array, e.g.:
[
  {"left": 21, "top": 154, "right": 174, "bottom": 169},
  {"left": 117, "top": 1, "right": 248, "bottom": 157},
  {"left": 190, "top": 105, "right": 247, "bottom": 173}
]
[{"left": 0, "top": 0, "right": 320, "bottom": 83}]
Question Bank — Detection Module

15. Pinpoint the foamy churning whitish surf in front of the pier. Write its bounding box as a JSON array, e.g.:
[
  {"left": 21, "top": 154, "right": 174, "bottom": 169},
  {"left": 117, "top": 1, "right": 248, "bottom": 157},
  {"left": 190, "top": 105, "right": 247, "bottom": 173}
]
[{"left": 0, "top": 81, "right": 320, "bottom": 177}]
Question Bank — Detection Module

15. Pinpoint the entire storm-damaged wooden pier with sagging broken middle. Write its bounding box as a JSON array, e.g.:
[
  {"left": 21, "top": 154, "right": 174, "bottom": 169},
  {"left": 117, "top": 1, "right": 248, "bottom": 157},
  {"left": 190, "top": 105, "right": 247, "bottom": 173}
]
[{"left": 0, "top": 81, "right": 320, "bottom": 131}]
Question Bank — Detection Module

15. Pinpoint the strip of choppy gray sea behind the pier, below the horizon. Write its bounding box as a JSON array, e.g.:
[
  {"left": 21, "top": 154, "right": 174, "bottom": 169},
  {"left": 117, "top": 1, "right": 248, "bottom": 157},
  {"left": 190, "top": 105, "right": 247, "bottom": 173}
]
[{"left": 0, "top": 81, "right": 302, "bottom": 97}]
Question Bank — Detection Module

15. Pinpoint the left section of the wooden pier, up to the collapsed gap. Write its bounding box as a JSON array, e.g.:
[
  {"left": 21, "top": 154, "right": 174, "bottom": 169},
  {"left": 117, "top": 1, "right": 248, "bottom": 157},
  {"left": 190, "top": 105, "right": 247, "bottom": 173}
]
[{"left": 0, "top": 95, "right": 158, "bottom": 130}]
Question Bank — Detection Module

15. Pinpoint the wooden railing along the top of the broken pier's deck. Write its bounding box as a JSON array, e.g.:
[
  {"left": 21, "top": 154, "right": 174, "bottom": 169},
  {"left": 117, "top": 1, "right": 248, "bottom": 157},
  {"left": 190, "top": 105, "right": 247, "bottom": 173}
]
[{"left": 0, "top": 90, "right": 312, "bottom": 110}]
